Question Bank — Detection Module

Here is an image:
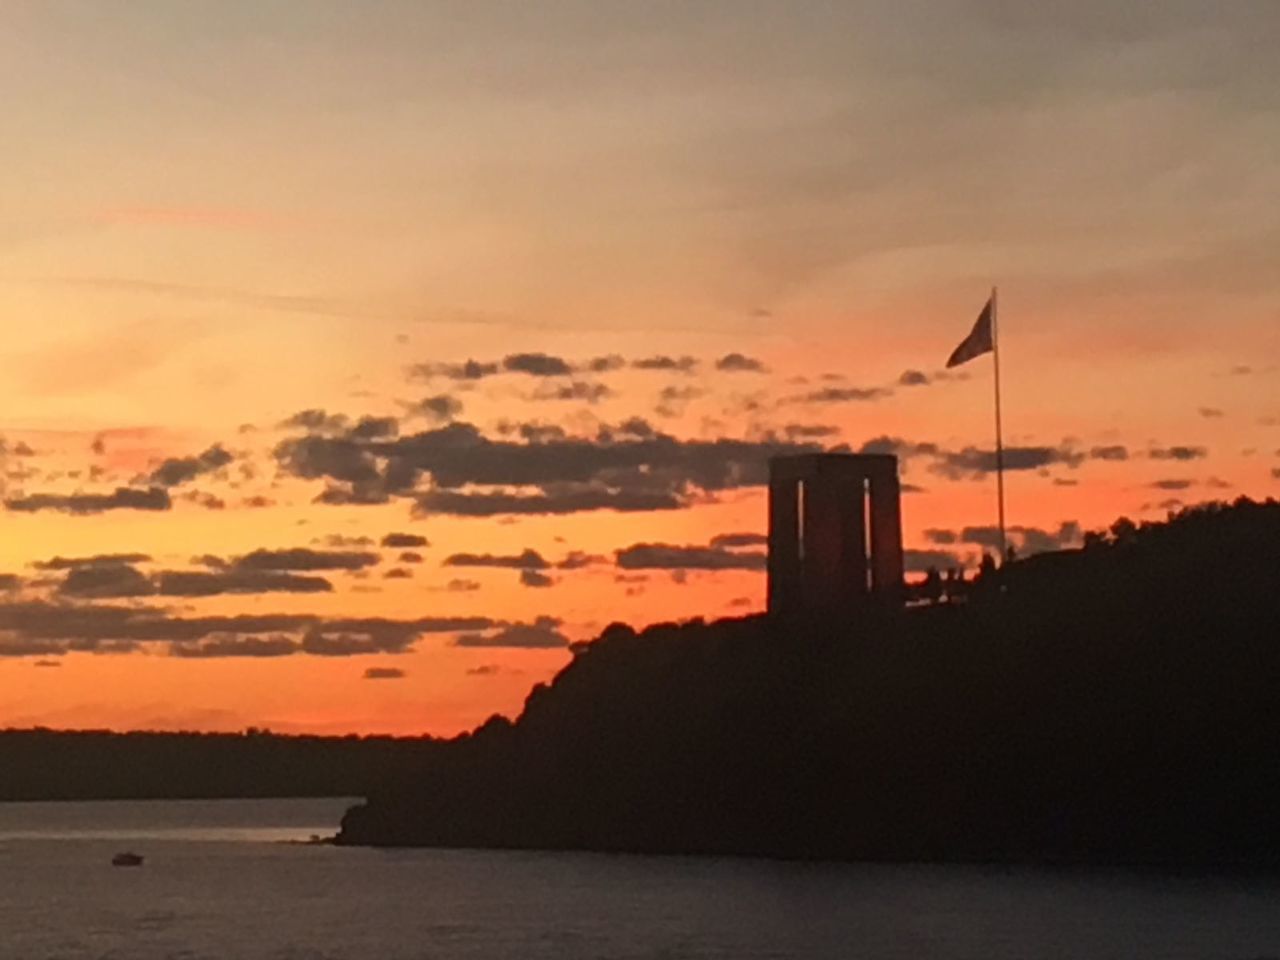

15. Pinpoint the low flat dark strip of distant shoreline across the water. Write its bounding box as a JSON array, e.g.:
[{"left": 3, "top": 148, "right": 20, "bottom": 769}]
[{"left": 0, "top": 730, "right": 439, "bottom": 800}]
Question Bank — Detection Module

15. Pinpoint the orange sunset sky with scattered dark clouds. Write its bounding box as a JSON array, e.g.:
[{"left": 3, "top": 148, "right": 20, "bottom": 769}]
[{"left": 0, "top": 0, "right": 1280, "bottom": 735}]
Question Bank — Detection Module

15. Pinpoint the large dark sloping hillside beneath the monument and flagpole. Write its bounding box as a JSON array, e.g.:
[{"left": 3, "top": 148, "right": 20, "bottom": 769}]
[{"left": 338, "top": 499, "right": 1280, "bottom": 864}]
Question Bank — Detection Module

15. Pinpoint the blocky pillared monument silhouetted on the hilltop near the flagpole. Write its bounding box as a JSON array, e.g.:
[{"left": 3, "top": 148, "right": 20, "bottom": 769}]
[{"left": 768, "top": 453, "right": 902, "bottom": 617}]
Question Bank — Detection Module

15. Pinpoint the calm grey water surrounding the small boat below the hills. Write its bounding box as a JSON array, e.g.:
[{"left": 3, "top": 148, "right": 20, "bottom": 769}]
[{"left": 0, "top": 800, "right": 1280, "bottom": 960}]
